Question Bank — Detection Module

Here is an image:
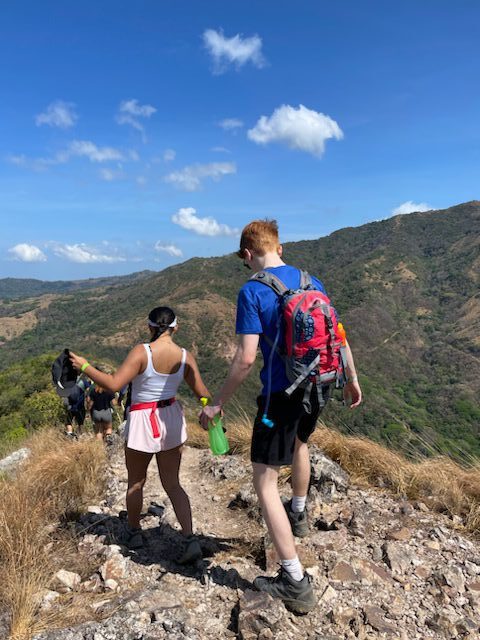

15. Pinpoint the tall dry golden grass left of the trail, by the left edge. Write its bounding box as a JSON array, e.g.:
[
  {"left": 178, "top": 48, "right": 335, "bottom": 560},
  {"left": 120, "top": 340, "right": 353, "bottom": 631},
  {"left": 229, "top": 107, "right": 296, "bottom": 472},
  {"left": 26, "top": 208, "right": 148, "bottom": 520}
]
[{"left": 0, "top": 431, "right": 106, "bottom": 640}]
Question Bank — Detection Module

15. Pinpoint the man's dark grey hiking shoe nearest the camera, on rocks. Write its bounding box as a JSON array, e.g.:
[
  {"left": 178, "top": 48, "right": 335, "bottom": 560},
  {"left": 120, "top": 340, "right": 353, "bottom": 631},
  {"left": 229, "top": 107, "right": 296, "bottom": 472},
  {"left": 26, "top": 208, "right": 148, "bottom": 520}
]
[{"left": 253, "top": 567, "right": 317, "bottom": 613}]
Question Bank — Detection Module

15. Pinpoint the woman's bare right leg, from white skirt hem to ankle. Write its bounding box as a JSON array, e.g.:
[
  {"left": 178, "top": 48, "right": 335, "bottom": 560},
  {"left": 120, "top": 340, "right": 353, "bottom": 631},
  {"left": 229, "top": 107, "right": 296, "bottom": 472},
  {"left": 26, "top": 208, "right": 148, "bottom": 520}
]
[{"left": 156, "top": 446, "right": 192, "bottom": 536}]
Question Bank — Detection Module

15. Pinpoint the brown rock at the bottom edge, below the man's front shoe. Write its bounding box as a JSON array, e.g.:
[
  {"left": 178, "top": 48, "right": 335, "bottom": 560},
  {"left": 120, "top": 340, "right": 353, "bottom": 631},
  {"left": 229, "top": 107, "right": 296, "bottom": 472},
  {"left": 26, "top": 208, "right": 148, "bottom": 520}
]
[{"left": 238, "top": 589, "right": 286, "bottom": 640}]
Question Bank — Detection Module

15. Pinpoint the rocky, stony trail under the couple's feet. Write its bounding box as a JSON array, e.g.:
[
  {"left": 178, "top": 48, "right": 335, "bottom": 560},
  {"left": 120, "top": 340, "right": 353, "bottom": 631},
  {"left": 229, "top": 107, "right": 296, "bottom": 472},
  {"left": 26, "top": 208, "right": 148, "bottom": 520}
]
[{"left": 35, "top": 443, "right": 480, "bottom": 640}]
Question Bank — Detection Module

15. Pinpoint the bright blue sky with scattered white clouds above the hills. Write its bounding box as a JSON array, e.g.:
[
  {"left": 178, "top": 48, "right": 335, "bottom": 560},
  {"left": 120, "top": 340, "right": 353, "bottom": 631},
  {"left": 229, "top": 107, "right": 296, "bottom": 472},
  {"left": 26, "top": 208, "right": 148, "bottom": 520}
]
[{"left": 0, "top": 0, "right": 480, "bottom": 279}]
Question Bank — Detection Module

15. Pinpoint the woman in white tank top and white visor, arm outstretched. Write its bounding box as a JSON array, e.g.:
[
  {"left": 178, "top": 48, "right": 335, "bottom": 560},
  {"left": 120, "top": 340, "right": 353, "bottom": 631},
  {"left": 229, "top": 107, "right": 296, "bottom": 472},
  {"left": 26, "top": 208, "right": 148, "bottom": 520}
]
[{"left": 70, "top": 307, "right": 210, "bottom": 564}]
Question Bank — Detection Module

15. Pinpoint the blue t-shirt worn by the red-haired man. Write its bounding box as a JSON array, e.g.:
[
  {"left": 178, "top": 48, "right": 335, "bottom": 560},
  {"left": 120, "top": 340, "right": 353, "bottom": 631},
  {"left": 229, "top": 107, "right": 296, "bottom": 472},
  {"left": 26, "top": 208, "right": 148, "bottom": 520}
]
[{"left": 236, "top": 264, "right": 326, "bottom": 395}]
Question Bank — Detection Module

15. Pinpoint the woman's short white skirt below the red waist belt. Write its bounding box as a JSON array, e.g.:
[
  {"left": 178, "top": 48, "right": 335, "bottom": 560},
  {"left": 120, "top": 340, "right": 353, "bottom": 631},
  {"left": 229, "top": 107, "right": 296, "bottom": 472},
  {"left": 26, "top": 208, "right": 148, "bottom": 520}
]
[{"left": 125, "top": 400, "right": 187, "bottom": 453}]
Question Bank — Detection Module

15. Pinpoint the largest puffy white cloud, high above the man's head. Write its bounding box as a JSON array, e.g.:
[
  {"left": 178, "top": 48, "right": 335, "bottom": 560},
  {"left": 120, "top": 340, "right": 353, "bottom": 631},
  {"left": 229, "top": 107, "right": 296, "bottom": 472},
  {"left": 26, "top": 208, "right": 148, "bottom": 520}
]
[{"left": 248, "top": 104, "right": 343, "bottom": 157}]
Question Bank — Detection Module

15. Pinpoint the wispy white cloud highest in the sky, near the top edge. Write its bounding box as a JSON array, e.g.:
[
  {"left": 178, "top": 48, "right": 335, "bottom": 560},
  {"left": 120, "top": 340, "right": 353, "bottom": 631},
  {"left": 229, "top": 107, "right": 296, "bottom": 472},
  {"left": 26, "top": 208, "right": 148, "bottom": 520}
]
[{"left": 203, "top": 29, "right": 265, "bottom": 73}]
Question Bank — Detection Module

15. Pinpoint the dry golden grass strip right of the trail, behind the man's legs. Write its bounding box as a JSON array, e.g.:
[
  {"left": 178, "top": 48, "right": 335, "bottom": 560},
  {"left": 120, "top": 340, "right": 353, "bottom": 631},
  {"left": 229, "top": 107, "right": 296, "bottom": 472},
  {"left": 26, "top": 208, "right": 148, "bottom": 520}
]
[{"left": 189, "top": 416, "right": 480, "bottom": 535}]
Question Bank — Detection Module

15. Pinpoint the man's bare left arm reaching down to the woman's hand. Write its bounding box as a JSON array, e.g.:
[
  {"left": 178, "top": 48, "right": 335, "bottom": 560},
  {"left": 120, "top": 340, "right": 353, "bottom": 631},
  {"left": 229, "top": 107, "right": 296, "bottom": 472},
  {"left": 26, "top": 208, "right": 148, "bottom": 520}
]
[{"left": 200, "top": 333, "right": 260, "bottom": 429}]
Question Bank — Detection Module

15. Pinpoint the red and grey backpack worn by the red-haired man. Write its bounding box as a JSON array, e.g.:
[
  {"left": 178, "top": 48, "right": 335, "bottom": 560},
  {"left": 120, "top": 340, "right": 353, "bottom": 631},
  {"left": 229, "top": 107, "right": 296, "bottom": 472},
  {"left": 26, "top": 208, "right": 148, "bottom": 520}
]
[{"left": 251, "top": 271, "right": 346, "bottom": 426}]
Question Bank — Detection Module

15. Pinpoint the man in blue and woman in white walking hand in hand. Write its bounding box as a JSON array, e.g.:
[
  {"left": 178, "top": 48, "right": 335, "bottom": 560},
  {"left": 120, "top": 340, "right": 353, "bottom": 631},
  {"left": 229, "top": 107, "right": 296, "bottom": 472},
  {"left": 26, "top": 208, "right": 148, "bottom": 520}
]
[{"left": 72, "top": 220, "right": 362, "bottom": 613}]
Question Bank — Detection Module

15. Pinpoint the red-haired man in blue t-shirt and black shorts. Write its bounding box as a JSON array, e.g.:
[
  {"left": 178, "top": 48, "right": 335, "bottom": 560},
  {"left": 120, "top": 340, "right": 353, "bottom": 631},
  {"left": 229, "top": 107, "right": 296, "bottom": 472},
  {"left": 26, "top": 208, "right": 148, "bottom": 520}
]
[{"left": 200, "top": 220, "right": 362, "bottom": 613}]
